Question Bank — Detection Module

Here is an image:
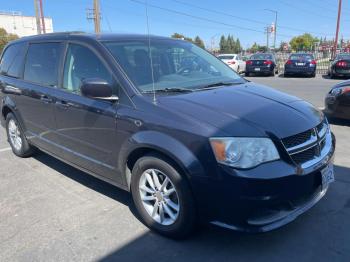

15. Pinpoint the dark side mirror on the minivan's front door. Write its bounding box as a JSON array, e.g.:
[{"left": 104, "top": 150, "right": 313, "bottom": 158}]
[{"left": 80, "top": 78, "right": 118, "bottom": 102}]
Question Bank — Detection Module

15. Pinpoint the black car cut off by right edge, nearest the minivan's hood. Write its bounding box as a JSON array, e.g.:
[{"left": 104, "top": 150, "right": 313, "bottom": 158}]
[{"left": 325, "top": 81, "right": 350, "bottom": 119}]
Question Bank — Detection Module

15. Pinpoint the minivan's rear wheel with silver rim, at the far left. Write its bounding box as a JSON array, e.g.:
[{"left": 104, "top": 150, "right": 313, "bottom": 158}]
[{"left": 6, "top": 113, "right": 35, "bottom": 157}]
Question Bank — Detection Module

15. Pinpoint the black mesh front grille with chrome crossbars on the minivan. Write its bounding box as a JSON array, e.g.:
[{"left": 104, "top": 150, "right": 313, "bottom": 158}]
[{"left": 282, "top": 119, "right": 332, "bottom": 167}]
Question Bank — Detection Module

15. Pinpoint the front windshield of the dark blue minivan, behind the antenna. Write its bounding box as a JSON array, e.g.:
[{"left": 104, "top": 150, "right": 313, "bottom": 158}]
[{"left": 103, "top": 39, "right": 246, "bottom": 93}]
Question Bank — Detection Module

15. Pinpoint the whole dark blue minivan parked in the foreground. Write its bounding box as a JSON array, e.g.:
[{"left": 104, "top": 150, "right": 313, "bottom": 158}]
[{"left": 0, "top": 33, "right": 335, "bottom": 238}]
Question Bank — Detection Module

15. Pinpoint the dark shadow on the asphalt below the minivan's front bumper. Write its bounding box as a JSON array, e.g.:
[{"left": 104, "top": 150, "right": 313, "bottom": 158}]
[{"left": 99, "top": 166, "right": 350, "bottom": 262}]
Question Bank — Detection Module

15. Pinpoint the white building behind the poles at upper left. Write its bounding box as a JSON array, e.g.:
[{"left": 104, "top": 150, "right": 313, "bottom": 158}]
[{"left": 0, "top": 11, "right": 53, "bottom": 37}]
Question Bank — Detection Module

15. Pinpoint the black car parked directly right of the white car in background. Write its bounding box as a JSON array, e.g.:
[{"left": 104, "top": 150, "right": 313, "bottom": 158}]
[{"left": 245, "top": 53, "right": 278, "bottom": 76}]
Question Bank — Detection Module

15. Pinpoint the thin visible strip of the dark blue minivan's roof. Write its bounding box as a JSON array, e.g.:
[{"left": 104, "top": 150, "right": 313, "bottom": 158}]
[{"left": 12, "top": 32, "right": 178, "bottom": 43}]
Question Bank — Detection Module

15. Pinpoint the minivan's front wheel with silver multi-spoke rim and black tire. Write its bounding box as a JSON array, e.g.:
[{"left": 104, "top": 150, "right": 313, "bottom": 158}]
[{"left": 131, "top": 155, "right": 196, "bottom": 239}]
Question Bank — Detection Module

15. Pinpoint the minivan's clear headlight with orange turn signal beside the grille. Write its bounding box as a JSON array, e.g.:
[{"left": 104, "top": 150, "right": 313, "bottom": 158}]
[{"left": 210, "top": 137, "right": 280, "bottom": 168}]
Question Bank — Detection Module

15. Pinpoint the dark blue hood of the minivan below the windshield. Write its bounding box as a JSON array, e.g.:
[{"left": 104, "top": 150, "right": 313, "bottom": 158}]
[{"left": 158, "top": 83, "right": 323, "bottom": 138}]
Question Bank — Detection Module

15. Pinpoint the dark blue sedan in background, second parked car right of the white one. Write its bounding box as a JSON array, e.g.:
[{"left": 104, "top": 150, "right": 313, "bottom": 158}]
[{"left": 284, "top": 53, "right": 317, "bottom": 77}]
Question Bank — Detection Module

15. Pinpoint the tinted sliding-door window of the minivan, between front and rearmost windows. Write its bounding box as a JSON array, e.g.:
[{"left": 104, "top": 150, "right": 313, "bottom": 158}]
[{"left": 24, "top": 43, "right": 62, "bottom": 86}]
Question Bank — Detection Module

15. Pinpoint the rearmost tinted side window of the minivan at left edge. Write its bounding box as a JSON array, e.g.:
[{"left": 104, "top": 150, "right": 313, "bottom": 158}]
[{"left": 0, "top": 43, "right": 25, "bottom": 78}]
